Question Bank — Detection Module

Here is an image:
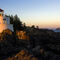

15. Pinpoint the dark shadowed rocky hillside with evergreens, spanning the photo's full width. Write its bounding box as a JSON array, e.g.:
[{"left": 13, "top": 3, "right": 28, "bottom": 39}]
[{"left": 0, "top": 15, "right": 60, "bottom": 60}]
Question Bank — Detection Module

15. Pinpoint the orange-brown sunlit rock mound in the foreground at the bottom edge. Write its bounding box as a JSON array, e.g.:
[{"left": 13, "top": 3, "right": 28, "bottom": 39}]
[{"left": 5, "top": 50, "right": 38, "bottom": 60}]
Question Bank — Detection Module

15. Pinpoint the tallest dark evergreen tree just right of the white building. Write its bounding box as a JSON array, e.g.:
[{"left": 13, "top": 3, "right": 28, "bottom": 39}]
[{"left": 13, "top": 15, "right": 23, "bottom": 32}]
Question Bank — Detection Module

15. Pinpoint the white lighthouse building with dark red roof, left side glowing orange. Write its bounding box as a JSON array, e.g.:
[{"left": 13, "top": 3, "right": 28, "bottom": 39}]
[{"left": 0, "top": 9, "right": 13, "bottom": 33}]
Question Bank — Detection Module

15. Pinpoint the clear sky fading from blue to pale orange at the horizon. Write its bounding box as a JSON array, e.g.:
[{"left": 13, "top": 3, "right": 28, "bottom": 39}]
[{"left": 0, "top": 0, "right": 60, "bottom": 28}]
